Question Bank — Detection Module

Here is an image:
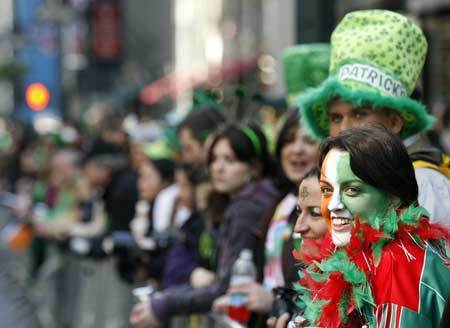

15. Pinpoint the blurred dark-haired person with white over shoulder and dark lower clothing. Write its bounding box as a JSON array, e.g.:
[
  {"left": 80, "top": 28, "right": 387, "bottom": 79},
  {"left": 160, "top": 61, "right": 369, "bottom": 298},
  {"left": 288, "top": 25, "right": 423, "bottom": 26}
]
[{"left": 120, "top": 139, "right": 177, "bottom": 281}]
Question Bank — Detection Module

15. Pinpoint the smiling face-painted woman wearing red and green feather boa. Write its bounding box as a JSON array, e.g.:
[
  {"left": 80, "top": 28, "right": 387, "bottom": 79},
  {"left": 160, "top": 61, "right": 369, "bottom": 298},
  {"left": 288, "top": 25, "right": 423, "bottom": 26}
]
[{"left": 299, "top": 127, "right": 450, "bottom": 327}]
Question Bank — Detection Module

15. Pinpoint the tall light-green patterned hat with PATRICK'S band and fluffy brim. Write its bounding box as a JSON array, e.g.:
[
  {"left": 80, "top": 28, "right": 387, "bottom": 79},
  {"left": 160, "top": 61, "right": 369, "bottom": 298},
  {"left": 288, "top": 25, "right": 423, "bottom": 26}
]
[{"left": 298, "top": 10, "right": 434, "bottom": 139}]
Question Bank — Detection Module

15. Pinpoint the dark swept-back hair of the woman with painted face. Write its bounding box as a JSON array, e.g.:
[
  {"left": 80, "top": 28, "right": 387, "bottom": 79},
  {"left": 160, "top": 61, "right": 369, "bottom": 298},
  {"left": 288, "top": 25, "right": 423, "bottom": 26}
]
[{"left": 319, "top": 126, "right": 418, "bottom": 206}]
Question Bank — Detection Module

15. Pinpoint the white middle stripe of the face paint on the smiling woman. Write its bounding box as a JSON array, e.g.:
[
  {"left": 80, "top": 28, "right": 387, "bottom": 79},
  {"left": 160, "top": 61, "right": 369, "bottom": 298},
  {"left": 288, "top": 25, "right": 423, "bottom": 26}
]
[{"left": 321, "top": 149, "right": 353, "bottom": 247}]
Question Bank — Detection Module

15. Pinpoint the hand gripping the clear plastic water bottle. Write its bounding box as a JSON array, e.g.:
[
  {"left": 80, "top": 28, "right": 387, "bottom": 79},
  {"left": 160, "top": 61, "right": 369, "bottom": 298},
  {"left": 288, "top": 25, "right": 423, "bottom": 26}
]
[{"left": 227, "top": 282, "right": 273, "bottom": 313}]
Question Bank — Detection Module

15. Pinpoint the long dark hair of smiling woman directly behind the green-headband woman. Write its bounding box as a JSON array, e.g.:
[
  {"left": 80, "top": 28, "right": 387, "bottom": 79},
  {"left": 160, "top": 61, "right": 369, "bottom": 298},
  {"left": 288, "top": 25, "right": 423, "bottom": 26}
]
[{"left": 274, "top": 109, "right": 300, "bottom": 192}]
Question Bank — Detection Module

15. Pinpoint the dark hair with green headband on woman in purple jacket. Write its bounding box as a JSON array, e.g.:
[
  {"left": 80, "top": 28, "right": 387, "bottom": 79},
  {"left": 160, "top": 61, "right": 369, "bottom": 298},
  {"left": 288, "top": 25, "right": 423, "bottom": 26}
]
[{"left": 207, "top": 123, "right": 273, "bottom": 177}]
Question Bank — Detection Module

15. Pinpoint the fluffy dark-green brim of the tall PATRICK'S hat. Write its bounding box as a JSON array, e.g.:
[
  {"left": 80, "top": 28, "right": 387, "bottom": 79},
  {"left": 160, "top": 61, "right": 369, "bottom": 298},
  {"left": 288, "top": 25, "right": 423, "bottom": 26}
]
[{"left": 298, "top": 77, "right": 435, "bottom": 139}]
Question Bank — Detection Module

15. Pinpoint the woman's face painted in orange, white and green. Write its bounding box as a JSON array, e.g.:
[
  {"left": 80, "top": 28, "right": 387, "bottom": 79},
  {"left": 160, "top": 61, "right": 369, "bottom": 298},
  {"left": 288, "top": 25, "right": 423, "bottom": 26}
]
[{"left": 320, "top": 149, "right": 391, "bottom": 246}]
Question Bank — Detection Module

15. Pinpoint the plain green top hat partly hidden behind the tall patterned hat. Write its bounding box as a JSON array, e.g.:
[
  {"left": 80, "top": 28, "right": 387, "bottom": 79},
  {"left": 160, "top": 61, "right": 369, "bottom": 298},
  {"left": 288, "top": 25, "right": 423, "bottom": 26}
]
[{"left": 282, "top": 43, "right": 330, "bottom": 106}]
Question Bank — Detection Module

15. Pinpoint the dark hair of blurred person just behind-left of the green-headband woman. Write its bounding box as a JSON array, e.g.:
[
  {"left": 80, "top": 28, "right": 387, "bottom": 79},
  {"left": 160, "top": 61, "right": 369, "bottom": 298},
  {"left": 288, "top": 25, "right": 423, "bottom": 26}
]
[{"left": 177, "top": 107, "right": 227, "bottom": 144}]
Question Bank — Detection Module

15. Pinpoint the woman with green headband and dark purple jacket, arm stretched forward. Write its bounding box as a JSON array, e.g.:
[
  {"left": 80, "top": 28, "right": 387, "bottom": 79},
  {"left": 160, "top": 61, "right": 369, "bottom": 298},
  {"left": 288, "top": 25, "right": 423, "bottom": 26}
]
[{"left": 130, "top": 125, "right": 277, "bottom": 327}]
